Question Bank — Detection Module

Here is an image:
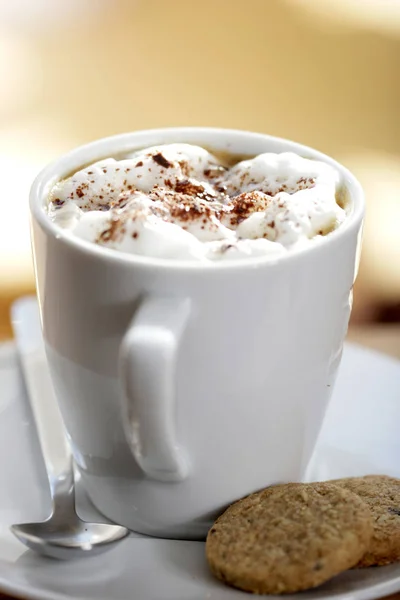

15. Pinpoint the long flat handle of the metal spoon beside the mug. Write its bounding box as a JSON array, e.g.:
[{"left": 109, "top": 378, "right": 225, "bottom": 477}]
[{"left": 11, "top": 296, "right": 73, "bottom": 501}]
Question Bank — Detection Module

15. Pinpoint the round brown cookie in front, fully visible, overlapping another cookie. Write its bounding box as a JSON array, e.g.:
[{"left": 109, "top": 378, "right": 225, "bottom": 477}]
[{"left": 206, "top": 483, "right": 373, "bottom": 594}]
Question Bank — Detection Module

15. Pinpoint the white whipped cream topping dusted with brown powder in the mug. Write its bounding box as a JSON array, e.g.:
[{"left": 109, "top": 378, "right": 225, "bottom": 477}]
[{"left": 48, "top": 144, "right": 346, "bottom": 261}]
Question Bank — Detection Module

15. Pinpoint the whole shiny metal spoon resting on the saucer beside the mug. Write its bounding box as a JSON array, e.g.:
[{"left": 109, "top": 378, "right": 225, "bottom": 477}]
[{"left": 11, "top": 297, "right": 129, "bottom": 559}]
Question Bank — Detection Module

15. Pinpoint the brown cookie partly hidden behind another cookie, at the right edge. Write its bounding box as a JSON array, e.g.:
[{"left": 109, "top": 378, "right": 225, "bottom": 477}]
[{"left": 332, "top": 475, "right": 400, "bottom": 567}]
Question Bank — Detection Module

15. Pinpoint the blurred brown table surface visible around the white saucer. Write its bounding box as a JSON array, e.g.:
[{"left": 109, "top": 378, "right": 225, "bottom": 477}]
[{"left": 0, "top": 325, "right": 400, "bottom": 600}]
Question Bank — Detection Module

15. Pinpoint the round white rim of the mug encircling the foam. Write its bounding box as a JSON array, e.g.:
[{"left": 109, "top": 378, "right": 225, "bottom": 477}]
[{"left": 29, "top": 127, "right": 365, "bottom": 272}]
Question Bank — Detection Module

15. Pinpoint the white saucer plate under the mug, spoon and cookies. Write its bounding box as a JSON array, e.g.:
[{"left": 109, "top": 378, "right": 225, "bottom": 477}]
[{"left": 0, "top": 343, "right": 400, "bottom": 600}]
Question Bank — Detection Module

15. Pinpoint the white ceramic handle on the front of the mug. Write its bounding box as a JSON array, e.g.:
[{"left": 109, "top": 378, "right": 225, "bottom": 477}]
[{"left": 119, "top": 296, "right": 190, "bottom": 481}]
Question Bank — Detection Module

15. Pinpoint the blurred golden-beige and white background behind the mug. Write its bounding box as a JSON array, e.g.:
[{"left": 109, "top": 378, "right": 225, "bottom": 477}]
[{"left": 0, "top": 0, "right": 400, "bottom": 354}]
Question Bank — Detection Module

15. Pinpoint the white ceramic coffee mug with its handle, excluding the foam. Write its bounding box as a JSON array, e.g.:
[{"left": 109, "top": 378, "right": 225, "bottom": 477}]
[{"left": 30, "top": 128, "right": 364, "bottom": 539}]
